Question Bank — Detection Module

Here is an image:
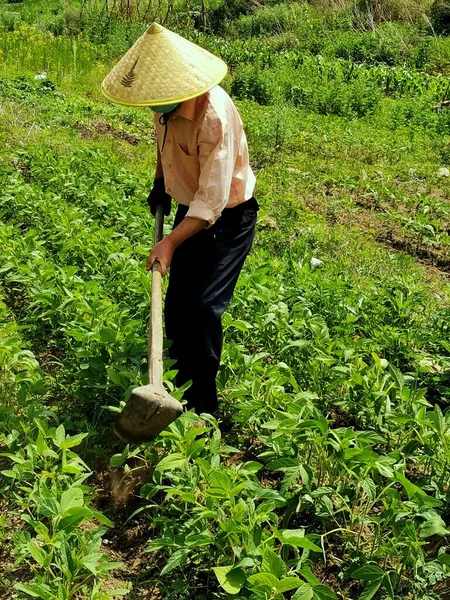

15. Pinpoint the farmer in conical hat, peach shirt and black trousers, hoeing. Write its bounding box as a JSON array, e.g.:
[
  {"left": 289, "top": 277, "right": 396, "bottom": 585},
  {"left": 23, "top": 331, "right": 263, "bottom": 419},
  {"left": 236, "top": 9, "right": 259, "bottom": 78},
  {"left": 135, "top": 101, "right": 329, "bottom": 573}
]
[{"left": 102, "top": 23, "right": 258, "bottom": 413}]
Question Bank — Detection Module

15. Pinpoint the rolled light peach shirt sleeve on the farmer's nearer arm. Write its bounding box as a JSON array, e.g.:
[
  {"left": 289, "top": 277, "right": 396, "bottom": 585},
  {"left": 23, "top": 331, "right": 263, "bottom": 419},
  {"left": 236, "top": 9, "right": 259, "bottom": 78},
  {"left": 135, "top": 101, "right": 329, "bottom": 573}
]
[{"left": 186, "top": 111, "right": 238, "bottom": 226}]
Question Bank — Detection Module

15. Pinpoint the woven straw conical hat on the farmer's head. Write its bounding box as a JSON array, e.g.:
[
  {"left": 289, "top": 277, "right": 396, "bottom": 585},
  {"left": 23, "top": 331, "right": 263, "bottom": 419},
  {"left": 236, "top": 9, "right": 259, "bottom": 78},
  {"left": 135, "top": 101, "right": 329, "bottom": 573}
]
[{"left": 102, "top": 23, "right": 227, "bottom": 106}]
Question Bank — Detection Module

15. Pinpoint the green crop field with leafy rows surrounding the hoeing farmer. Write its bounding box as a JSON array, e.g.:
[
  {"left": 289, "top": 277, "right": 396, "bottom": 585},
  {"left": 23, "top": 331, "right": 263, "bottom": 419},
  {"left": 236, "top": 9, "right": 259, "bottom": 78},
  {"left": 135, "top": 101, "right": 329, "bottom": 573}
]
[{"left": 0, "top": 0, "right": 450, "bottom": 600}]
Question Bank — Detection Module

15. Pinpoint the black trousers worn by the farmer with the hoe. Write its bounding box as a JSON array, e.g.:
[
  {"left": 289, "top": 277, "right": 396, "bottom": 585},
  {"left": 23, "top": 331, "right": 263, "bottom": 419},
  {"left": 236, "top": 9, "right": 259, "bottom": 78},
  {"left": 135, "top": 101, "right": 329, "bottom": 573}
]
[{"left": 165, "top": 198, "right": 258, "bottom": 414}]
